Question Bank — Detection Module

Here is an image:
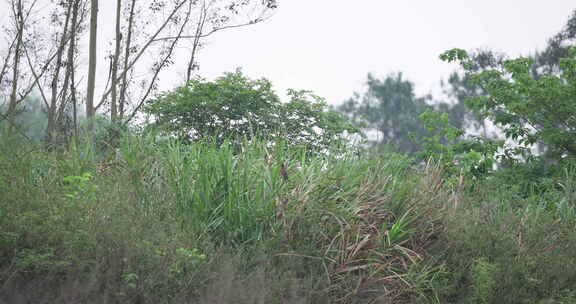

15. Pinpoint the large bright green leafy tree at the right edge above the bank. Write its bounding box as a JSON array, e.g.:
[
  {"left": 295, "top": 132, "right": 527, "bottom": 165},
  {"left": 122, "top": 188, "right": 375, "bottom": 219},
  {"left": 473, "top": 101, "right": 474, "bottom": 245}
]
[{"left": 430, "top": 11, "right": 576, "bottom": 189}]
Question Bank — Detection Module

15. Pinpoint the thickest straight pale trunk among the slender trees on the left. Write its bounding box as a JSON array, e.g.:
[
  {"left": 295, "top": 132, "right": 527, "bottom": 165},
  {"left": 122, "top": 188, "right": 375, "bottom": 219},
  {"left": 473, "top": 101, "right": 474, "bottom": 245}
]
[{"left": 86, "top": 0, "right": 98, "bottom": 132}]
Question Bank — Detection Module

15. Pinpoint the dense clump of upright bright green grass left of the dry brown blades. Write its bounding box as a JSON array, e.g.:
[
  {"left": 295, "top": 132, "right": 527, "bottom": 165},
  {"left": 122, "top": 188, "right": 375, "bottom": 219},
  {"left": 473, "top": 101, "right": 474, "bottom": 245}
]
[{"left": 154, "top": 141, "right": 284, "bottom": 245}]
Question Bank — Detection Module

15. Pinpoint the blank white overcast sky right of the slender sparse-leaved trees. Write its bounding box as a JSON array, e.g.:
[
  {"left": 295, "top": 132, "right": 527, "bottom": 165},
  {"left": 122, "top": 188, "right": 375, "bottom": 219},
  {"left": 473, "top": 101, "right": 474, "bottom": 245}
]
[{"left": 0, "top": 0, "right": 576, "bottom": 104}]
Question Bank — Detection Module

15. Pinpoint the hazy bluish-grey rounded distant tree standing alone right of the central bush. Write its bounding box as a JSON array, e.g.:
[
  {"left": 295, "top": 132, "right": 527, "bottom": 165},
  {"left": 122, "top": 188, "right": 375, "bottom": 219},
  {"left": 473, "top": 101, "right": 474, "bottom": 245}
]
[{"left": 338, "top": 73, "right": 430, "bottom": 153}]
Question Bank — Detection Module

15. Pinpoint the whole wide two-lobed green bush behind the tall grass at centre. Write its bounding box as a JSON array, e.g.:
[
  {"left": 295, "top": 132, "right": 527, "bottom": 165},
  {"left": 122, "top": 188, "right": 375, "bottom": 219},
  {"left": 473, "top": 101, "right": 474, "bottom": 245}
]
[{"left": 144, "top": 70, "right": 359, "bottom": 150}]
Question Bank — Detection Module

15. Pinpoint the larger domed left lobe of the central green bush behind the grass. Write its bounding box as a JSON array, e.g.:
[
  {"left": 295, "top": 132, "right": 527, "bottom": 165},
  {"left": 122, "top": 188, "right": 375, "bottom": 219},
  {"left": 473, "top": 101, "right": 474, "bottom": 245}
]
[{"left": 145, "top": 71, "right": 280, "bottom": 140}]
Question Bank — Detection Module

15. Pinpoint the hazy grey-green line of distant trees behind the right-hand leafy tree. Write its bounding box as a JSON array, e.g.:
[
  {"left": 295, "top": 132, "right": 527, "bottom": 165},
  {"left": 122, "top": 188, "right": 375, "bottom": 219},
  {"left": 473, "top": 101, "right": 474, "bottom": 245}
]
[{"left": 336, "top": 11, "right": 576, "bottom": 162}]
